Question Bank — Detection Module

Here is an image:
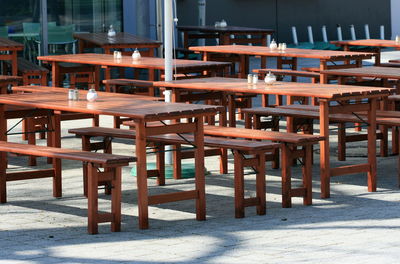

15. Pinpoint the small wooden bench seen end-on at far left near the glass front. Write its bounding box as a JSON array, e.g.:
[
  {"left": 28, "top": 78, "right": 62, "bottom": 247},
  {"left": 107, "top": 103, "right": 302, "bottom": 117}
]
[{"left": 18, "top": 58, "right": 49, "bottom": 86}]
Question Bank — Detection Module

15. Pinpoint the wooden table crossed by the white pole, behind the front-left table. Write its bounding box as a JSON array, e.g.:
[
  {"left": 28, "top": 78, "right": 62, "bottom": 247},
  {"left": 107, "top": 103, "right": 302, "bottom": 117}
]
[{"left": 38, "top": 53, "right": 230, "bottom": 89}]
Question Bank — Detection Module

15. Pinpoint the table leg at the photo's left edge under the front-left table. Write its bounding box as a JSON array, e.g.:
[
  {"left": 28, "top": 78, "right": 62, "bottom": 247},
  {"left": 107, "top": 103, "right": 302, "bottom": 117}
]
[{"left": 0, "top": 104, "right": 7, "bottom": 203}]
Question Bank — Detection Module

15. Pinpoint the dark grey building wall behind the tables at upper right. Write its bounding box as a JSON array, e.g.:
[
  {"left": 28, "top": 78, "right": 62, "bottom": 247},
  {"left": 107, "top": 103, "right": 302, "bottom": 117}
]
[{"left": 177, "top": 0, "right": 391, "bottom": 42}]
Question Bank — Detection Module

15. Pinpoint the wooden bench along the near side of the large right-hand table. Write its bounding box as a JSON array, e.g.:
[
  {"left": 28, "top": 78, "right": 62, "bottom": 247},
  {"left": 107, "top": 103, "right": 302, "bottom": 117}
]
[{"left": 99, "top": 121, "right": 323, "bottom": 207}]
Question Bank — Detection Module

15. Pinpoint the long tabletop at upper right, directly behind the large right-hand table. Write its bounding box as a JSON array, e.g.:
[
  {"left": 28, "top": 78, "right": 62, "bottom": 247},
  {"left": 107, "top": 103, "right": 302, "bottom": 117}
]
[{"left": 189, "top": 45, "right": 372, "bottom": 59}]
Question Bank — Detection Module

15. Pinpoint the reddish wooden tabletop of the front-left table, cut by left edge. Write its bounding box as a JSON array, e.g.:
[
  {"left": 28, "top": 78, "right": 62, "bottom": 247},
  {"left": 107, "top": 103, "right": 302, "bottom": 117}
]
[{"left": 0, "top": 92, "right": 222, "bottom": 121}]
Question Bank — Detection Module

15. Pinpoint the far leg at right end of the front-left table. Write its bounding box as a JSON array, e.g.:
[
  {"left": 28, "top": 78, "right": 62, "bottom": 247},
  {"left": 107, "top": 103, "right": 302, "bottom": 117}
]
[{"left": 194, "top": 117, "right": 206, "bottom": 220}]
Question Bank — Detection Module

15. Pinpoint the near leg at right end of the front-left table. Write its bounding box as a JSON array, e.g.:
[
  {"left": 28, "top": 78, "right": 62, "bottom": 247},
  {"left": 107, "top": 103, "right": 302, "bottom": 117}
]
[{"left": 135, "top": 120, "right": 149, "bottom": 229}]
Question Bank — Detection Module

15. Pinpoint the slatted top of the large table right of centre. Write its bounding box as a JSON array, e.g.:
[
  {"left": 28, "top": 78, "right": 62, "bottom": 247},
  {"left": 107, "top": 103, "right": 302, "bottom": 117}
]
[{"left": 154, "top": 77, "right": 394, "bottom": 100}]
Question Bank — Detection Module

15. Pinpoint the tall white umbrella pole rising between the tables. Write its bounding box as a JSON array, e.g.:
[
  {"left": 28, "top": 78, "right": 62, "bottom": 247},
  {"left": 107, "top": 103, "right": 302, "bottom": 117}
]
[{"left": 164, "top": 0, "right": 173, "bottom": 165}]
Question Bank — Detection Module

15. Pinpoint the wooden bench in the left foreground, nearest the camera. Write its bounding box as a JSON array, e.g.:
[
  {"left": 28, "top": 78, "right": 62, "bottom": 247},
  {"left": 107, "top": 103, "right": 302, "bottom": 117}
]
[{"left": 0, "top": 141, "right": 135, "bottom": 234}]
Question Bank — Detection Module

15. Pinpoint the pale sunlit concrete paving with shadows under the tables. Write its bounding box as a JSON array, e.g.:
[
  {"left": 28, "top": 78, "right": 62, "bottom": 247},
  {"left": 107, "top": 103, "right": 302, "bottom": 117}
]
[{"left": 0, "top": 50, "right": 400, "bottom": 264}]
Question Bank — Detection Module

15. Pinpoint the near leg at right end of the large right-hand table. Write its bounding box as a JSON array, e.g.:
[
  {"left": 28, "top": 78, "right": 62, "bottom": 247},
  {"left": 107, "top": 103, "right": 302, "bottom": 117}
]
[{"left": 319, "top": 99, "right": 330, "bottom": 198}]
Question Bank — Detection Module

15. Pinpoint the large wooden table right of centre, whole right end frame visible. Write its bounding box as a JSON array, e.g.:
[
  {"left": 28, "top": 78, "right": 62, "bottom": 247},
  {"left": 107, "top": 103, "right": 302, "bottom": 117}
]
[{"left": 155, "top": 77, "right": 392, "bottom": 198}]
